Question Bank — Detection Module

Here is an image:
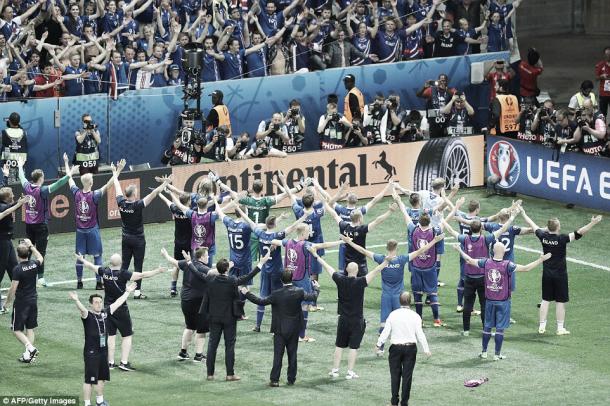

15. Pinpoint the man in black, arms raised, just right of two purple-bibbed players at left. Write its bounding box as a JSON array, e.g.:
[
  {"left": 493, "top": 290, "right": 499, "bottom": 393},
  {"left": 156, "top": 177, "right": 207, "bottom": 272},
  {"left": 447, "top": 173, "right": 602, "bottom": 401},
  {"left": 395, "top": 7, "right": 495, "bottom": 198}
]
[{"left": 112, "top": 159, "right": 167, "bottom": 299}]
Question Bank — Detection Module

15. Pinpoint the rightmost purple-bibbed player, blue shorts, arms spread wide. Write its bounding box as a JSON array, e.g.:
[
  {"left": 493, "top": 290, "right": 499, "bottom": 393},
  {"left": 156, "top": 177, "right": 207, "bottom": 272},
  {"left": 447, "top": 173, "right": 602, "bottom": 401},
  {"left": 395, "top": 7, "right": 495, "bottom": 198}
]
[{"left": 454, "top": 241, "right": 551, "bottom": 361}]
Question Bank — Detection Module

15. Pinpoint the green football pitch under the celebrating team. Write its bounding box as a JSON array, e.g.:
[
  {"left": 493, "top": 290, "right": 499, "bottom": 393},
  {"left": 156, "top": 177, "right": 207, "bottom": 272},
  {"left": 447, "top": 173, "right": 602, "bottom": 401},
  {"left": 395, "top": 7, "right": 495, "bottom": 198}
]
[{"left": 0, "top": 189, "right": 610, "bottom": 406}]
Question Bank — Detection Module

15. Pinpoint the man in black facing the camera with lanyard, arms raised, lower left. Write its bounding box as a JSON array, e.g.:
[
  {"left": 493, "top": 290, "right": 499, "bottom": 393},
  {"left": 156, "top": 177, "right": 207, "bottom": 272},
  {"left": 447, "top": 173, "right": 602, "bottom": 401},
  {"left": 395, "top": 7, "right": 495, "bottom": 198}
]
[{"left": 70, "top": 283, "right": 136, "bottom": 406}]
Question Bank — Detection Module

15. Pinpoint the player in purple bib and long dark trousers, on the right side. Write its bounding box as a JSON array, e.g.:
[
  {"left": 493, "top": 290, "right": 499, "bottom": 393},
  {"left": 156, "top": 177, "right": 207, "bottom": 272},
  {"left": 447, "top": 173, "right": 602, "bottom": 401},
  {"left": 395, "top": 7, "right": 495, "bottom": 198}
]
[{"left": 442, "top": 205, "right": 520, "bottom": 336}]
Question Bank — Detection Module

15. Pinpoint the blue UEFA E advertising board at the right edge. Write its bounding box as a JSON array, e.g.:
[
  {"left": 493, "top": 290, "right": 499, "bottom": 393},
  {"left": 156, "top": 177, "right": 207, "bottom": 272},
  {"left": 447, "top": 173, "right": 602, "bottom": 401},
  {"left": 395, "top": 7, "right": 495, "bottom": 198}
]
[{"left": 487, "top": 136, "right": 610, "bottom": 211}]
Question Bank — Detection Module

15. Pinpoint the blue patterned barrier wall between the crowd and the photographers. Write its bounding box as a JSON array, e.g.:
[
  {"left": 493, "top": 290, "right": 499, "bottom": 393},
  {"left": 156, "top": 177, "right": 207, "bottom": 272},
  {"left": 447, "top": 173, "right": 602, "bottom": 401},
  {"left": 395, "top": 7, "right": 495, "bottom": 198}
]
[{"left": 2, "top": 52, "right": 508, "bottom": 177}]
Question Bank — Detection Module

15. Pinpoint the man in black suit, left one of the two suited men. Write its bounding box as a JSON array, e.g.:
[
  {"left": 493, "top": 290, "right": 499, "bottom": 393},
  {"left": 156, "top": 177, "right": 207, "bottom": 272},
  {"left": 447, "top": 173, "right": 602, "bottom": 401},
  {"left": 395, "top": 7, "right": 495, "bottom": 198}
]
[{"left": 202, "top": 254, "right": 270, "bottom": 381}]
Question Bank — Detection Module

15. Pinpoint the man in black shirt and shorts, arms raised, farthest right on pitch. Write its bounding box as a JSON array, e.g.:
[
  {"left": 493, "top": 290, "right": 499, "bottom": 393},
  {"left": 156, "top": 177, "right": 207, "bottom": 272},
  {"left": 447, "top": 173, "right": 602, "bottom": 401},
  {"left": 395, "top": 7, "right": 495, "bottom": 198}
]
[{"left": 521, "top": 210, "right": 602, "bottom": 336}]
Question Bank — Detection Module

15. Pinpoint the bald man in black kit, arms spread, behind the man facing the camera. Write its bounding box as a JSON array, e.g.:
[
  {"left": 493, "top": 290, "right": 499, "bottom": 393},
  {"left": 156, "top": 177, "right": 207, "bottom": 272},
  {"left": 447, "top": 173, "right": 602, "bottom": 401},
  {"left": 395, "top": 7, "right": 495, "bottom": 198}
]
[{"left": 75, "top": 253, "right": 167, "bottom": 371}]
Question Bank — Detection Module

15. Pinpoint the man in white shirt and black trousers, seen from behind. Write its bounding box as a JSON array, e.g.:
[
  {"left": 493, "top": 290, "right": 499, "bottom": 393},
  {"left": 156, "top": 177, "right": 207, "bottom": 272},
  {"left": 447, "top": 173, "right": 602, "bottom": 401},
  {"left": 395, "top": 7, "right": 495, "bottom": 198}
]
[{"left": 377, "top": 292, "right": 432, "bottom": 406}]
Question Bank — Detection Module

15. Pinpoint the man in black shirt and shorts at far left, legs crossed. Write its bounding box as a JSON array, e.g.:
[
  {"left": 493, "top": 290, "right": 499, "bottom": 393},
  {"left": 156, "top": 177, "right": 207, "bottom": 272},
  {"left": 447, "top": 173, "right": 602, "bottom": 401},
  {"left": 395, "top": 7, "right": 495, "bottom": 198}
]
[{"left": 6, "top": 239, "right": 43, "bottom": 364}]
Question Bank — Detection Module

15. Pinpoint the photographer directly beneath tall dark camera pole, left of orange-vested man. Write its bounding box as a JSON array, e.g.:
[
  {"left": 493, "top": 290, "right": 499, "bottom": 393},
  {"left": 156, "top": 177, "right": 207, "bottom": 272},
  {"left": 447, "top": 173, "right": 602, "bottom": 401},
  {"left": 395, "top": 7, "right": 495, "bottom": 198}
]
[{"left": 161, "top": 109, "right": 205, "bottom": 166}]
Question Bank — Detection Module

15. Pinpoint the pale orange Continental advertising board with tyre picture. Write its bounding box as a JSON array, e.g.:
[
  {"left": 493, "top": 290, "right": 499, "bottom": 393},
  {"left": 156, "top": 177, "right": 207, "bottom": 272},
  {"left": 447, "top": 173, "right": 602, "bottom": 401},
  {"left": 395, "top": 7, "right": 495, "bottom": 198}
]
[{"left": 13, "top": 135, "right": 484, "bottom": 237}]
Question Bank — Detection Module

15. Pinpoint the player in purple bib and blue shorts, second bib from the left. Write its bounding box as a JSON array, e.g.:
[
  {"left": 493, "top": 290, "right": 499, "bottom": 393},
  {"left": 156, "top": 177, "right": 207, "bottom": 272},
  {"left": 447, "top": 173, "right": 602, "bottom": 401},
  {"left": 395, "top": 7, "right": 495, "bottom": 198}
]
[{"left": 64, "top": 160, "right": 120, "bottom": 290}]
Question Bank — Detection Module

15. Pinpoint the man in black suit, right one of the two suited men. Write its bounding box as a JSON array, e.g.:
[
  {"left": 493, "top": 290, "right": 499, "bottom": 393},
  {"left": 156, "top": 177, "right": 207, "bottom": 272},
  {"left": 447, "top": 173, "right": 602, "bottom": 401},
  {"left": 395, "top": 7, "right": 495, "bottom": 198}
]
[{"left": 240, "top": 271, "right": 320, "bottom": 387}]
